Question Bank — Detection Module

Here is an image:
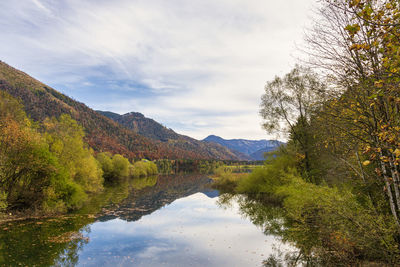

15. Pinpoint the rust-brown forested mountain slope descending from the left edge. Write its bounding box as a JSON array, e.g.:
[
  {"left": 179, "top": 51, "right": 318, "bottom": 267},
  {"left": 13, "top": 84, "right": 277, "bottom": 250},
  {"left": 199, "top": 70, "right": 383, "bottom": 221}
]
[{"left": 0, "top": 61, "right": 239, "bottom": 160}]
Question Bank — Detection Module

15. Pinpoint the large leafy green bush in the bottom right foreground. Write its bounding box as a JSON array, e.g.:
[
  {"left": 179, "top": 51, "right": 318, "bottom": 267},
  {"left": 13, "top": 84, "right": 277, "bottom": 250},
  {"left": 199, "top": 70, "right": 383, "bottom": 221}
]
[{"left": 277, "top": 175, "right": 399, "bottom": 264}]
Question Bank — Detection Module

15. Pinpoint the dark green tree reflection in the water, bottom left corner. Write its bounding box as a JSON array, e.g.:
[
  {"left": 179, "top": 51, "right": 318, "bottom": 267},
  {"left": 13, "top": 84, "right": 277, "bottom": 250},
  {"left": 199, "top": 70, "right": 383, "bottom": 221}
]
[{"left": 0, "top": 216, "right": 94, "bottom": 266}]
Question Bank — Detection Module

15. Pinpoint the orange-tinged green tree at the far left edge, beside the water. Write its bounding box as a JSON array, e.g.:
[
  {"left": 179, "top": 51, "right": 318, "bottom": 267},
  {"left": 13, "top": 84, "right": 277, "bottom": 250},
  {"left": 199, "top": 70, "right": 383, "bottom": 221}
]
[{"left": 0, "top": 92, "right": 78, "bottom": 211}]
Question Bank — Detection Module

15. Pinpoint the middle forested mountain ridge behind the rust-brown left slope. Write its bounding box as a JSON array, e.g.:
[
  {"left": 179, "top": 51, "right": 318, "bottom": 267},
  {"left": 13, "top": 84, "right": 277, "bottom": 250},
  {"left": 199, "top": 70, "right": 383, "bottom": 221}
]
[{"left": 97, "top": 110, "right": 251, "bottom": 160}]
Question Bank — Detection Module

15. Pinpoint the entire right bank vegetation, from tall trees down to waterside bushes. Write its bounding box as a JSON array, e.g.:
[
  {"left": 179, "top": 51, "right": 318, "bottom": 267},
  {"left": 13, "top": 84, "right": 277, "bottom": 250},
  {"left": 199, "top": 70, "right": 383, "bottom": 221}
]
[{"left": 214, "top": 0, "right": 400, "bottom": 266}]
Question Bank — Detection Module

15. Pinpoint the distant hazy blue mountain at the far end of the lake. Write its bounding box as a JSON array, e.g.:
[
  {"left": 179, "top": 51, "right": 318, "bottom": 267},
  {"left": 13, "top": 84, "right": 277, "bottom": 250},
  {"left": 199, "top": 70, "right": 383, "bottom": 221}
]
[{"left": 203, "top": 135, "right": 283, "bottom": 160}]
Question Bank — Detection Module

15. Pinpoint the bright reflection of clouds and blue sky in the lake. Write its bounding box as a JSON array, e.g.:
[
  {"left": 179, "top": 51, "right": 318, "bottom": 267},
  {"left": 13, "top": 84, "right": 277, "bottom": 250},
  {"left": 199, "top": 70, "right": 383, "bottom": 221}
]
[{"left": 76, "top": 193, "right": 289, "bottom": 266}]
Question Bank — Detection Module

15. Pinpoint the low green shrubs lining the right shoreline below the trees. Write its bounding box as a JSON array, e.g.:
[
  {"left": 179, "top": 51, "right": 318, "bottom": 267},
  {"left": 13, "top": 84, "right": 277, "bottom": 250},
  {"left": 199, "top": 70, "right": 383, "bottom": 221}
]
[{"left": 213, "top": 151, "right": 400, "bottom": 266}]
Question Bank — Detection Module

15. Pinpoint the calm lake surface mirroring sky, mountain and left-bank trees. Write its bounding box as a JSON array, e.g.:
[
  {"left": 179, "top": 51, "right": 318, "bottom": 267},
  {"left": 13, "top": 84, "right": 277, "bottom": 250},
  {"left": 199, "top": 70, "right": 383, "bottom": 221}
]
[{"left": 0, "top": 175, "right": 292, "bottom": 266}]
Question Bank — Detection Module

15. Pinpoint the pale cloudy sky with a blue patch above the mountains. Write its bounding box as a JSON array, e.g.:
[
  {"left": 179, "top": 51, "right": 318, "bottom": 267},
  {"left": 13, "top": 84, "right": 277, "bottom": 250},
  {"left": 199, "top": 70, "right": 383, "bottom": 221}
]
[{"left": 0, "top": 0, "right": 316, "bottom": 139}]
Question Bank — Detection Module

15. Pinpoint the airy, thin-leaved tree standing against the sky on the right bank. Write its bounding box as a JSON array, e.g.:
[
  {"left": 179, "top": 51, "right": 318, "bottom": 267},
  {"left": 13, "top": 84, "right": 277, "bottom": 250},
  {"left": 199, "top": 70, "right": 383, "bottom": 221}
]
[{"left": 260, "top": 66, "right": 326, "bottom": 181}]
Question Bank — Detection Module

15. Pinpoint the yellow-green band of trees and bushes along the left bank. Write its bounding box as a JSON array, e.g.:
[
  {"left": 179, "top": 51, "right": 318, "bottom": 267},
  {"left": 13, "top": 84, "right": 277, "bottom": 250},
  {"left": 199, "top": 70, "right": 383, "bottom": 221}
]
[{"left": 0, "top": 91, "right": 157, "bottom": 218}]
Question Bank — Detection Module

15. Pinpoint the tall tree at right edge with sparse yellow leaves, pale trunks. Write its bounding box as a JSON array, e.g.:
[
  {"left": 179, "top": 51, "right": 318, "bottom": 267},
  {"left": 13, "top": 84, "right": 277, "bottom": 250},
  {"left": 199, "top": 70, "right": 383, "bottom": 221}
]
[{"left": 307, "top": 0, "right": 400, "bottom": 228}]
